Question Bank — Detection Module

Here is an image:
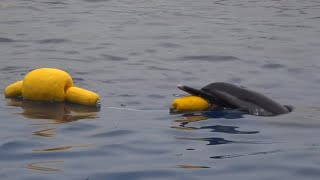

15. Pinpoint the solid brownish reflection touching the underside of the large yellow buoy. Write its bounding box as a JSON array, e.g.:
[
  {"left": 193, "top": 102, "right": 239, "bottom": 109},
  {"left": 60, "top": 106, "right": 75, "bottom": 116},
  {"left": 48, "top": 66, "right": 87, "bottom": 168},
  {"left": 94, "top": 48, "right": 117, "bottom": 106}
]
[{"left": 7, "top": 99, "right": 100, "bottom": 124}]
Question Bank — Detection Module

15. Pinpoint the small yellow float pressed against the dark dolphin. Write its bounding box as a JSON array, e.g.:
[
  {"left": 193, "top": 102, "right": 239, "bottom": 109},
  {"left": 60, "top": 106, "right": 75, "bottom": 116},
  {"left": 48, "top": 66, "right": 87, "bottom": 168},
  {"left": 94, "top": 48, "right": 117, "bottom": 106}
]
[{"left": 171, "top": 96, "right": 209, "bottom": 112}]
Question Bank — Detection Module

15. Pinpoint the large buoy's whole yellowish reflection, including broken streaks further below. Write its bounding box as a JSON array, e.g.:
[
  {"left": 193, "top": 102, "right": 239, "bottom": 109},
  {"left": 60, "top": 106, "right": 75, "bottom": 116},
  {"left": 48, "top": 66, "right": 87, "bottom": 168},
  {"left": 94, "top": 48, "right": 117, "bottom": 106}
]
[{"left": 7, "top": 99, "right": 100, "bottom": 171}]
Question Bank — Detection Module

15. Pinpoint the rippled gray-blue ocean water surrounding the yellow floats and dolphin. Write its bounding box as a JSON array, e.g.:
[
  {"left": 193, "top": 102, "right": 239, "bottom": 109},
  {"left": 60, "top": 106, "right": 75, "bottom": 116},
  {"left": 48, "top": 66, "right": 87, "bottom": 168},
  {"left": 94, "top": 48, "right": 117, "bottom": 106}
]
[{"left": 0, "top": 0, "right": 320, "bottom": 180}]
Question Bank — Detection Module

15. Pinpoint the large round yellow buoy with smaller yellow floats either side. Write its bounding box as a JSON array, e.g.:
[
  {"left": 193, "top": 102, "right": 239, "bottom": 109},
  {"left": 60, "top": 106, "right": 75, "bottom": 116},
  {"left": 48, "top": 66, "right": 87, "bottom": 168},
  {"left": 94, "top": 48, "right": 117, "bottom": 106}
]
[{"left": 4, "top": 68, "right": 100, "bottom": 106}]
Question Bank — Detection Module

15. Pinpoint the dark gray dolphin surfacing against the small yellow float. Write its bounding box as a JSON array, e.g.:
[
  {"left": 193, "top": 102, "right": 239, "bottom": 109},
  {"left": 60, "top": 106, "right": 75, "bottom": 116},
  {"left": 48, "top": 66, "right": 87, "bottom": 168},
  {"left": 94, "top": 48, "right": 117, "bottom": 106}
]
[{"left": 178, "top": 82, "right": 291, "bottom": 116}]
